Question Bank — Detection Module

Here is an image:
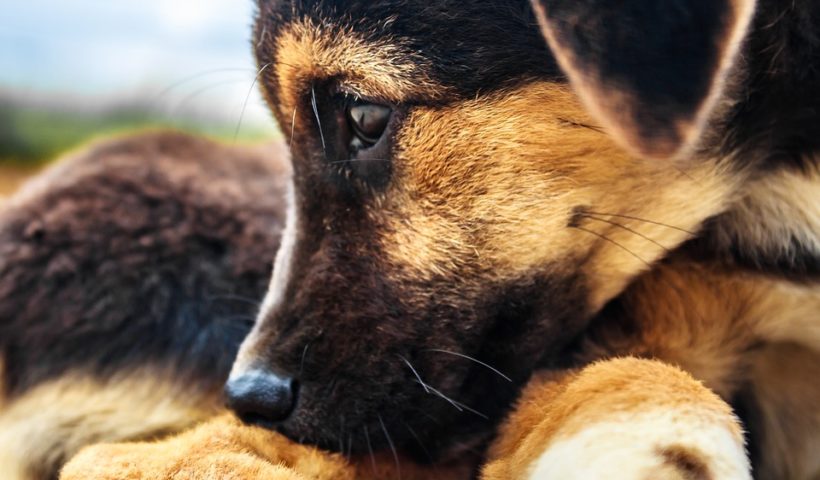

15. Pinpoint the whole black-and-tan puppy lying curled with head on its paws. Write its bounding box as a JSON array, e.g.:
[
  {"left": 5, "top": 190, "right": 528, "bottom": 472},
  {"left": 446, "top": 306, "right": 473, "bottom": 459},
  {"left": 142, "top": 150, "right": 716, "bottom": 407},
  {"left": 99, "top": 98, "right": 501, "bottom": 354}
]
[{"left": 0, "top": 0, "right": 820, "bottom": 479}]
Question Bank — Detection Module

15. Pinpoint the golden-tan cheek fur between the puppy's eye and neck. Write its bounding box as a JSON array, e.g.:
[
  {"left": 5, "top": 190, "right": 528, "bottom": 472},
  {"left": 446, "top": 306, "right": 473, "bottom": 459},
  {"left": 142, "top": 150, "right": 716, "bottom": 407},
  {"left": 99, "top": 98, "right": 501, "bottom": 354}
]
[{"left": 380, "top": 82, "right": 734, "bottom": 309}]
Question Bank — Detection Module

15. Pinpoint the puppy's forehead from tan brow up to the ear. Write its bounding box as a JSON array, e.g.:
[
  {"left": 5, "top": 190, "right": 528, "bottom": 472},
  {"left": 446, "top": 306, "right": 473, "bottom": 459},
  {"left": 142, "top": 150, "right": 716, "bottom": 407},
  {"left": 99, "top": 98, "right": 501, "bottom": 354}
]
[{"left": 257, "top": 0, "right": 562, "bottom": 97}]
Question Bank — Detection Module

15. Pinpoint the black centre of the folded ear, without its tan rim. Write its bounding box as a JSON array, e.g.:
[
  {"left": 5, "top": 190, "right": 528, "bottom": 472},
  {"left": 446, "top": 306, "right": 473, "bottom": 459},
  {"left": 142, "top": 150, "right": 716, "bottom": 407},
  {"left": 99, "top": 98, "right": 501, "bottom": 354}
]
[{"left": 533, "top": 0, "right": 732, "bottom": 152}]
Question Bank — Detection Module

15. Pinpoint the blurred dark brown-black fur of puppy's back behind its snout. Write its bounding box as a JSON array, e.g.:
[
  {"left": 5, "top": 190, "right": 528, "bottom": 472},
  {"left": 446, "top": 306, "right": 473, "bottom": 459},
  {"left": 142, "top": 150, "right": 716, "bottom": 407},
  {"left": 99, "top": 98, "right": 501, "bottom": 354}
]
[{"left": 0, "top": 133, "right": 288, "bottom": 397}]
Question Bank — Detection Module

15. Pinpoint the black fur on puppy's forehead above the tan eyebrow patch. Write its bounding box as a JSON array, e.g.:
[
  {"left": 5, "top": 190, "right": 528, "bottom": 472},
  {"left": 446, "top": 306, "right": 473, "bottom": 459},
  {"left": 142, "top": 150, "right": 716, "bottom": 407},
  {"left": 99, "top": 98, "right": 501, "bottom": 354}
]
[{"left": 257, "top": 0, "right": 563, "bottom": 101}]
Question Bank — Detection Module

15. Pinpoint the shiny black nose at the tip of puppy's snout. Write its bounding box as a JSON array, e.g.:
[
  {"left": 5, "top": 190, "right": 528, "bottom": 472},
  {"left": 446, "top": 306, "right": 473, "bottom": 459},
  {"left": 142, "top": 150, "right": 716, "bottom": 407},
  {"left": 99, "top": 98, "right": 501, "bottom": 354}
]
[{"left": 225, "top": 370, "right": 297, "bottom": 428}]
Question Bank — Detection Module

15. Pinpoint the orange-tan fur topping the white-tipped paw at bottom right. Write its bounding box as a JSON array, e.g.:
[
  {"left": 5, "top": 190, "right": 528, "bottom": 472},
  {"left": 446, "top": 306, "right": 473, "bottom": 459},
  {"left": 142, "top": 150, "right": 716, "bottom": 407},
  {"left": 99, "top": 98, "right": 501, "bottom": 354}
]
[{"left": 482, "top": 358, "right": 743, "bottom": 480}]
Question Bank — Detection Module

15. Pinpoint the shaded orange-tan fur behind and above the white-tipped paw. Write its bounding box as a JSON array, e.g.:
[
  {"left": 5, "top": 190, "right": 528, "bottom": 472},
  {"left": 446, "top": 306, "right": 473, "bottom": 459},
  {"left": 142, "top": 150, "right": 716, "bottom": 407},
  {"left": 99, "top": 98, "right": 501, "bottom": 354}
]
[{"left": 585, "top": 260, "right": 820, "bottom": 398}]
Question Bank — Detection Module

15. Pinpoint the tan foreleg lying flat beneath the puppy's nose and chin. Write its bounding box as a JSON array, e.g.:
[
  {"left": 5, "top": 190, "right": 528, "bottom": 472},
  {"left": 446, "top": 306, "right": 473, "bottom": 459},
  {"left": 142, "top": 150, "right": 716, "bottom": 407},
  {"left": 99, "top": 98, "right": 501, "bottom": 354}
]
[{"left": 60, "top": 415, "right": 468, "bottom": 480}]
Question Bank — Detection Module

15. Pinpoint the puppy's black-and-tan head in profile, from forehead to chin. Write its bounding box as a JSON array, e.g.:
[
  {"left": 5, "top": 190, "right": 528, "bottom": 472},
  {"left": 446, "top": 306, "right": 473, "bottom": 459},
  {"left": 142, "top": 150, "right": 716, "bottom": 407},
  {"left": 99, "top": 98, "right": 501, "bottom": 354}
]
[{"left": 229, "top": 0, "right": 756, "bottom": 456}]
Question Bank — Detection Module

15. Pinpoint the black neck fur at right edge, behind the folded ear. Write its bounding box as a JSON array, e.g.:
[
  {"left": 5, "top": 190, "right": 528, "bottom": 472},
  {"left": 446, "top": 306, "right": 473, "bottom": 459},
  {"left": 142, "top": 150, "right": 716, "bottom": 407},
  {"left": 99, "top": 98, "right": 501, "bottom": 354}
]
[{"left": 721, "top": 0, "right": 820, "bottom": 170}]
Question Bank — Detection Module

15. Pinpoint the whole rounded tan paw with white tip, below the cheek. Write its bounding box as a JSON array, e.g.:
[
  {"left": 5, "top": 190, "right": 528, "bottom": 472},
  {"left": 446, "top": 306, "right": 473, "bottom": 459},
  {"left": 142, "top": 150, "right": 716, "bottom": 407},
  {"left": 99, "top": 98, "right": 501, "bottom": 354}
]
[{"left": 482, "top": 358, "right": 751, "bottom": 480}]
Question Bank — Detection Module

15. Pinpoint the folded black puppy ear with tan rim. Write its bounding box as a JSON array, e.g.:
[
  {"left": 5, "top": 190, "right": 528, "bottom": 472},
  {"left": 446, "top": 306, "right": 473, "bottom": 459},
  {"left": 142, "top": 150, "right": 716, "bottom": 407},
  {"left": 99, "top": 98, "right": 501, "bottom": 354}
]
[{"left": 532, "top": 0, "right": 755, "bottom": 158}]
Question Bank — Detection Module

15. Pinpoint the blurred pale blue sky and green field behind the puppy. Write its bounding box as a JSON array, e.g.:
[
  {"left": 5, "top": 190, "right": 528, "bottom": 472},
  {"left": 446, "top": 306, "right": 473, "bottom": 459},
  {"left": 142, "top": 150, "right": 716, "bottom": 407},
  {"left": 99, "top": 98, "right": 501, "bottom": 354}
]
[{"left": 0, "top": 0, "right": 276, "bottom": 195}]
